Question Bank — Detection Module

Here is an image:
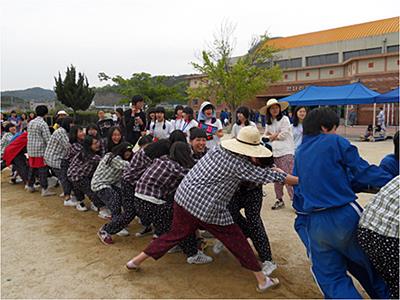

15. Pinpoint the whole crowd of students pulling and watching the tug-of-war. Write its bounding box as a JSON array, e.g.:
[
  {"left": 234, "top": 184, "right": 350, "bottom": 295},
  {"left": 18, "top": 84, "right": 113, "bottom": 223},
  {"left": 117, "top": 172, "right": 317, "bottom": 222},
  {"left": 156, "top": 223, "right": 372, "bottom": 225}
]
[{"left": 1, "top": 96, "right": 399, "bottom": 298}]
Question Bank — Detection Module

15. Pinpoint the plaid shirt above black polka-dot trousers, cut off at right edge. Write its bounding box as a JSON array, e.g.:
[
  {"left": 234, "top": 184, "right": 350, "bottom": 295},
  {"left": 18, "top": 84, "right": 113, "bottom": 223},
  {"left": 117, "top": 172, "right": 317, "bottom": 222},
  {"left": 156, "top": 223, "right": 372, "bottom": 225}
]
[{"left": 359, "top": 176, "right": 400, "bottom": 238}]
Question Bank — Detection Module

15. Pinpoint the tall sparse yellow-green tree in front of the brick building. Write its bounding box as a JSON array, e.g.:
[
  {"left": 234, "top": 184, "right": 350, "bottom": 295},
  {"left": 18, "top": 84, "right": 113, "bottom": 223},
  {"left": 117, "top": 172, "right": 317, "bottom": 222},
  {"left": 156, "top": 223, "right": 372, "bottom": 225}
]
[{"left": 187, "top": 24, "right": 282, "bottom": 118}]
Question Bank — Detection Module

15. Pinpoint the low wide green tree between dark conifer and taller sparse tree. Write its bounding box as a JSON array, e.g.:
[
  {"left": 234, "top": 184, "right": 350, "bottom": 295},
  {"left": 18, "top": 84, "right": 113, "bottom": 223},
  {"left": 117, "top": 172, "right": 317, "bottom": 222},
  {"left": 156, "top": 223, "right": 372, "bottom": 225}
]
[{"left": 98, "top": 72, "right": 186, "bottom": 104}]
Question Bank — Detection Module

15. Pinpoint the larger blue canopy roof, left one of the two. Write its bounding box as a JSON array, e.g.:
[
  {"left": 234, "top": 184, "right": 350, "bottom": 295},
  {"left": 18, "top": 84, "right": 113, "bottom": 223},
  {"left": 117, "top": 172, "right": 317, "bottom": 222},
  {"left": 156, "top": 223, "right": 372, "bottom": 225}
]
[{"left": 279, "top": 82, "right": 379, "bottom": 106}]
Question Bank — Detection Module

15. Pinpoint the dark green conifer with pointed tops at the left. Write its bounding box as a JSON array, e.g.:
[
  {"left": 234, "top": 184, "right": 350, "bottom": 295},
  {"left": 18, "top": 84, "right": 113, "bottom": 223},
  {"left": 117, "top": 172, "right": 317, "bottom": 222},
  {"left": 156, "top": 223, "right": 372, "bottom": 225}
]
[{"left": 54, "top": 65, "right": 95, "bottom": 115}]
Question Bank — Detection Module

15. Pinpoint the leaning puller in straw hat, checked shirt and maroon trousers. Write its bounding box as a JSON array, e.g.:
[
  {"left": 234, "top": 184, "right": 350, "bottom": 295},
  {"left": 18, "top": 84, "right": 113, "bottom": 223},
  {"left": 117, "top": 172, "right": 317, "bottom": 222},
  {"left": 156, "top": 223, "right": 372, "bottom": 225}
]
[{"left": 126, "top": 126, "right": 297, "bottom": 292}]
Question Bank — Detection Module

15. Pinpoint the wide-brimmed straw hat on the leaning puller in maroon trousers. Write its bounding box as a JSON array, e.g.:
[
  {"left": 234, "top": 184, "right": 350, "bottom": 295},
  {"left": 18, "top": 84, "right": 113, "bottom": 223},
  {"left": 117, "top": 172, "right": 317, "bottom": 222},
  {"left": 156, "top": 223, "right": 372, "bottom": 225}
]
[{"left": 221, "top": 126, "right": 272, "bottom": 157}]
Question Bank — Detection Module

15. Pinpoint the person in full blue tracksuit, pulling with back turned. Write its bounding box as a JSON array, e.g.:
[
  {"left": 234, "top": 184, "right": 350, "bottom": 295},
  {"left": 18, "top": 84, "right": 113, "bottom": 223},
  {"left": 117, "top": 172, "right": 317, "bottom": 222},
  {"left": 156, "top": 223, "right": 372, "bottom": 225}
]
[{"left": 293, "top": 108, "right": 391, "bottom": 299}]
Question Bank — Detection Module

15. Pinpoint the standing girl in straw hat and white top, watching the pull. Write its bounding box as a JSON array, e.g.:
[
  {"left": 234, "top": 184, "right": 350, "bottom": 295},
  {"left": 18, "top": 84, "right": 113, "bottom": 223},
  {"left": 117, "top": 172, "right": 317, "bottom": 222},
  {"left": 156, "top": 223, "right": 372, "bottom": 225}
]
[{"left": 264, "top": 99, "right": 294, "bottom": 209}]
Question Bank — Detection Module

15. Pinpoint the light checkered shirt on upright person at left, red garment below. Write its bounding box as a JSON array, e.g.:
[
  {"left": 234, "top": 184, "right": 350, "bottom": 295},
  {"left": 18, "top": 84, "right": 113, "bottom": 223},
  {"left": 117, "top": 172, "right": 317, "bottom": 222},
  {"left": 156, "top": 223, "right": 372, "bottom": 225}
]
[{"left": 27, "top": 117, "right": 51, "bottom": 157}]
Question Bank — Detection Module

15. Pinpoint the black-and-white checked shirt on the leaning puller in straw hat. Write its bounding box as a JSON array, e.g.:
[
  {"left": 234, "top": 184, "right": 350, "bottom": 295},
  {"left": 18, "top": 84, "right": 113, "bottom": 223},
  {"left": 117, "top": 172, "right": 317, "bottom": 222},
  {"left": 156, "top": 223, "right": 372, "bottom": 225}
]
[{"left": 175, "top": 146, "right": 286, "bottom": 226}]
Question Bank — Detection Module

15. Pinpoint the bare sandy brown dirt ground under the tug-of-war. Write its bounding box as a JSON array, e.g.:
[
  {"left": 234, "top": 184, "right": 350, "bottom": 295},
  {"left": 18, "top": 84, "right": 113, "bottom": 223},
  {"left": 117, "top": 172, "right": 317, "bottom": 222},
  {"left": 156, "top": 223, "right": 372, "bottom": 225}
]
[{"left": 1, "top": 140, "right": 393, "bottom": 298}]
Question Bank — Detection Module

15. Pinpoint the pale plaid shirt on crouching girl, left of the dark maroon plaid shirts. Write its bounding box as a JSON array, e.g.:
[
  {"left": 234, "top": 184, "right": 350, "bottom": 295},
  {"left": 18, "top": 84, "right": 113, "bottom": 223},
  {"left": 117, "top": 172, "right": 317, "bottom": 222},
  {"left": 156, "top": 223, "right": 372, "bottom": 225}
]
[{"left": 91, "top": 152, "right": 129, "bottom": 192}]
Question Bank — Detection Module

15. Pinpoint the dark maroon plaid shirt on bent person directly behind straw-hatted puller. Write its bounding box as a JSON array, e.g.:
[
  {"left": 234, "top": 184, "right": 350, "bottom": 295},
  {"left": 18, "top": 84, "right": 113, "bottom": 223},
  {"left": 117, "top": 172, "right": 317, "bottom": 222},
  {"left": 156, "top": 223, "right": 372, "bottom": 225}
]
[{"left": 135, "top": 155, "right": 189, "bottom": 201}]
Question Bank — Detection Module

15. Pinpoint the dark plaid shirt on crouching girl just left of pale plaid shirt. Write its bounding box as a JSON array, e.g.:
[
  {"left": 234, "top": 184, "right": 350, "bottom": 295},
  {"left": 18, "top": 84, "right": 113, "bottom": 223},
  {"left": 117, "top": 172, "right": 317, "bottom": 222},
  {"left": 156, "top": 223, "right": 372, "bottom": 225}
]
[{"left": 67, "top": 154, "right": 101, "bottom": 182}]
